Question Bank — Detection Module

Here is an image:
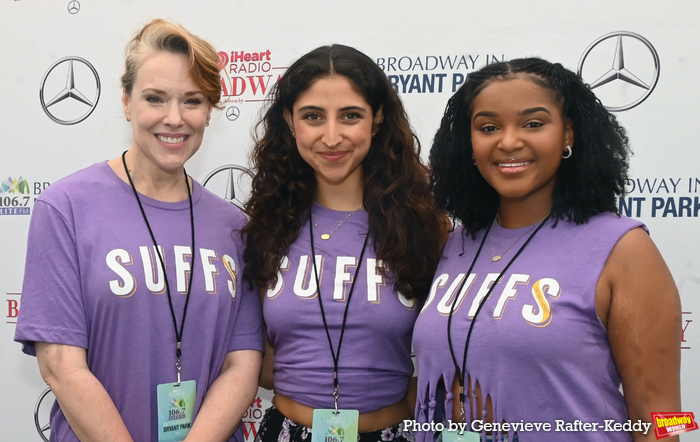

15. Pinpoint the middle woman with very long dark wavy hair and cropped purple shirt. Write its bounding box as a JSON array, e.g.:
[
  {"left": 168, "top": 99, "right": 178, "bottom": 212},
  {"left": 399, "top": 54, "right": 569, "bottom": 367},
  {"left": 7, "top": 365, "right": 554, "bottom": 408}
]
[{"left": 243, "top": 45, "right": 446, "bottom": 442}]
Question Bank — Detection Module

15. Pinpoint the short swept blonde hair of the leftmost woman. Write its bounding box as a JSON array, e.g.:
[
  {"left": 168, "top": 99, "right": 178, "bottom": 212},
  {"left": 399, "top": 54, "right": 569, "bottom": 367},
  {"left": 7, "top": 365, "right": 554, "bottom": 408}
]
[{"left": 121, "top": 19, "right": 221, "bottom": 108}]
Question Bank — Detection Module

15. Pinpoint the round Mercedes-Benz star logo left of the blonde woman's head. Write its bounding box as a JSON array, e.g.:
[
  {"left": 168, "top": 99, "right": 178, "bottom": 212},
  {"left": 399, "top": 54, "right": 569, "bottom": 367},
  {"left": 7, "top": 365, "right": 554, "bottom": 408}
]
[{"left": 39, "top": 57, "right": 101, "bottom": 125}]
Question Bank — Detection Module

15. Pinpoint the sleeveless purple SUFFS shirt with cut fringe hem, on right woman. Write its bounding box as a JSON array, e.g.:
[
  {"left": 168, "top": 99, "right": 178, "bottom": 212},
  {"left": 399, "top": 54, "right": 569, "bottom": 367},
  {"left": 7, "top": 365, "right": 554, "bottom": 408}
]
[{"left": 413, "top": 213, "right": 641, "bottom": 442}]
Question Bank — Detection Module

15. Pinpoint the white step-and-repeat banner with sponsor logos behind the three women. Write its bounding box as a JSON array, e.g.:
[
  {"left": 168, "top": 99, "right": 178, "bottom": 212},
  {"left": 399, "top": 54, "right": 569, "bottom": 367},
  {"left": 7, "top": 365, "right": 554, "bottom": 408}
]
[{"left": 0, "top": 0, "right": 700, "bottom": 441}]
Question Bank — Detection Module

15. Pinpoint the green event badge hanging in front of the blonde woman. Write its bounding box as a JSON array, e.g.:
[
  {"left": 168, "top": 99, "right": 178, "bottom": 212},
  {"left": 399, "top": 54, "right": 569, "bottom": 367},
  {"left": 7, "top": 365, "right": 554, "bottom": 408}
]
[{"left": 158, "top": 381, "right": 197, "bottom": 442}]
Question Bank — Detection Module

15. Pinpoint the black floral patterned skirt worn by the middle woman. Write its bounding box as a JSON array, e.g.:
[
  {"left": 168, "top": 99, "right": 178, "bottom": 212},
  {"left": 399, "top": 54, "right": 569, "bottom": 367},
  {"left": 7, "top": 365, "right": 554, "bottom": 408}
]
[{"left": 255, "top": 405, "right": 415, "bottom": 442}]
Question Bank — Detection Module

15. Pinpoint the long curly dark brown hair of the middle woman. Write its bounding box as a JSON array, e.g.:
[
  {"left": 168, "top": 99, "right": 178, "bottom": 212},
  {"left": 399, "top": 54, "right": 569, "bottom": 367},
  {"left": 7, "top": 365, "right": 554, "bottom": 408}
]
[{"left": 242, "top": 45, "right": 446, "bottom": 301}]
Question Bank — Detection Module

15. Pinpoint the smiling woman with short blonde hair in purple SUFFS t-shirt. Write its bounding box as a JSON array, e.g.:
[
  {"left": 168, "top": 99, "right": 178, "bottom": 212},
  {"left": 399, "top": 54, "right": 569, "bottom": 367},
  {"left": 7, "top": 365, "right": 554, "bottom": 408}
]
[{"left": 15, "top": 20, "right": 263, "bottom": 442}]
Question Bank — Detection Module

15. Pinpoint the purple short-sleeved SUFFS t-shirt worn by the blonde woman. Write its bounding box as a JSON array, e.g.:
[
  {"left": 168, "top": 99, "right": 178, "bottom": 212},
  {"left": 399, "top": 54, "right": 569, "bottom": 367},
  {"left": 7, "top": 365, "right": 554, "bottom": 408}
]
[{"left": 15, "top": 163, "right": 263, "bottom": 442}]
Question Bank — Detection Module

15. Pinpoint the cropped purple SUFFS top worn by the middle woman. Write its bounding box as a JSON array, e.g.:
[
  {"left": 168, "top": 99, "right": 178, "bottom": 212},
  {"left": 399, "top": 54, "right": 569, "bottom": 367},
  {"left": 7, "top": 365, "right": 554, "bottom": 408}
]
[{"left": 263, "top": 203, "right": 418, "bottom": 413}]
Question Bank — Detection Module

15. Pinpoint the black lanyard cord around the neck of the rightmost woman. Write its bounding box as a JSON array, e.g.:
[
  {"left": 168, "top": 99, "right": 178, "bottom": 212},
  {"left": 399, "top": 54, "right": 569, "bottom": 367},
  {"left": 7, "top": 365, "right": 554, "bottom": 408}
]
[{"left": 447, "top": 214, "right": 551, "bottom": 421}]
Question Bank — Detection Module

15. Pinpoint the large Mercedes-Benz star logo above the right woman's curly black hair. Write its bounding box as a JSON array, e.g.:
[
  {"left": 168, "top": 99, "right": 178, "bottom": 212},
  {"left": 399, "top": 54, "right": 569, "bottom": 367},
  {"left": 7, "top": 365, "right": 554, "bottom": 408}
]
[{"left": 578, "top": 31, "right": 661, "bottom": 112}]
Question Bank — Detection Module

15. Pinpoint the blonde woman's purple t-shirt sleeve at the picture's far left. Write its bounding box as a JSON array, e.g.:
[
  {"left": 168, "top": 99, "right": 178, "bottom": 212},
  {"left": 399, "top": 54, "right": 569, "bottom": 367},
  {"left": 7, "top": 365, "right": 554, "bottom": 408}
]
[{"left": 15, "top": 200, "right": 88, "bottom": 356}]
